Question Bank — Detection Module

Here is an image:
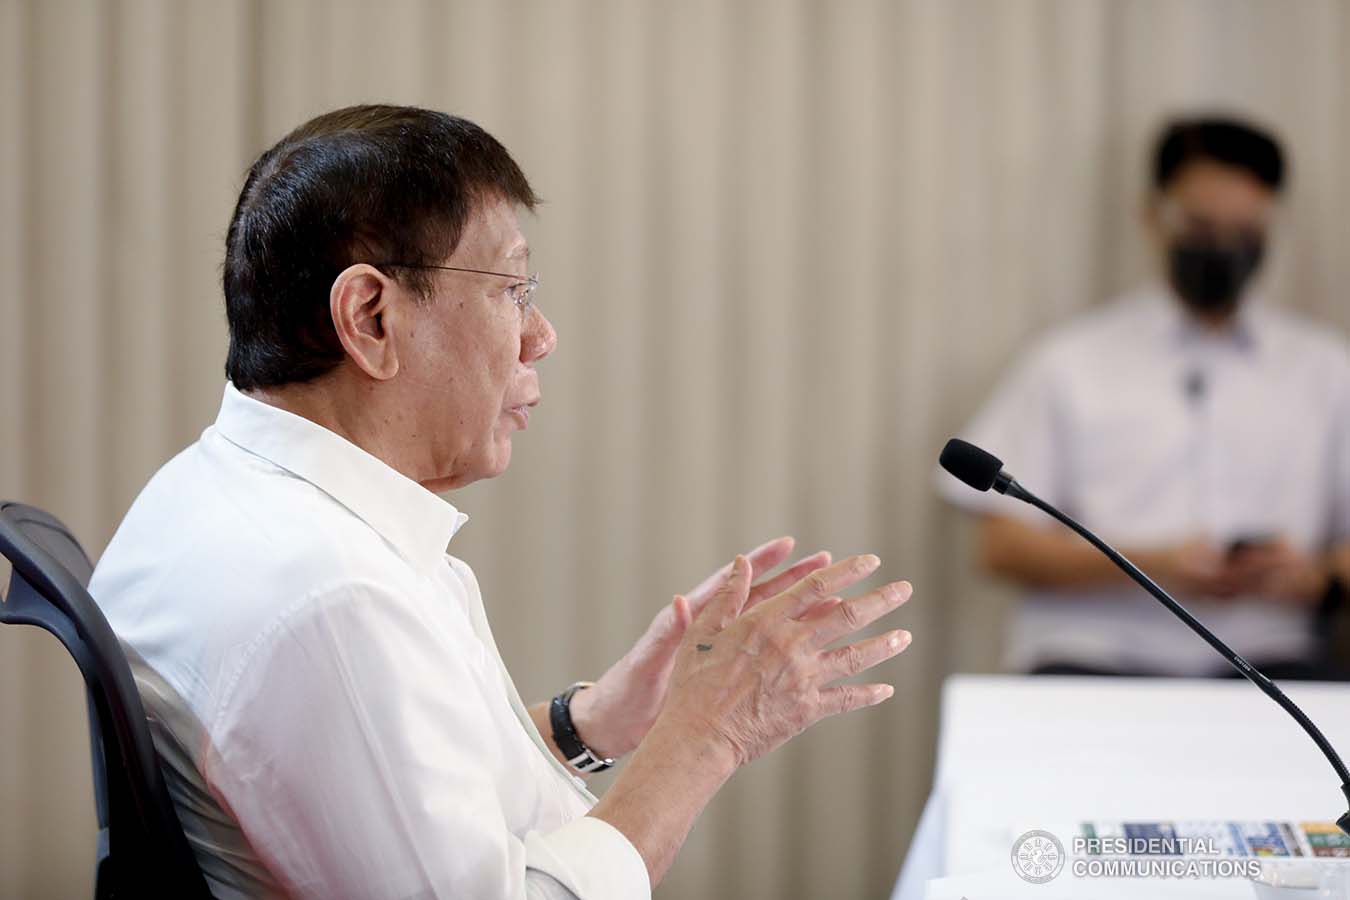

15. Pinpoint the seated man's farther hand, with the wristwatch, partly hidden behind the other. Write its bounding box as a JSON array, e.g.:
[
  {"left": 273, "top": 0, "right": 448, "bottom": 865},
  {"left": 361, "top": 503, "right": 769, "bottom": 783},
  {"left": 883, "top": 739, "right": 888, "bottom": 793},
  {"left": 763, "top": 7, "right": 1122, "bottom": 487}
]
[{"left": 571, "top": 537, "right": 830, "bottom": 758}]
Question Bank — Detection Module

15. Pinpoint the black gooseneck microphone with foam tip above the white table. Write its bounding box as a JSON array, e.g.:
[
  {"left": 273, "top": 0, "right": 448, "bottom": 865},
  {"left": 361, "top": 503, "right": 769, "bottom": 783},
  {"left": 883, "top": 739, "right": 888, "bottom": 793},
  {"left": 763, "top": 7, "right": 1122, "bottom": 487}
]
[{"left": 938, "top": 437, "right": 1350, "bottom": 835}]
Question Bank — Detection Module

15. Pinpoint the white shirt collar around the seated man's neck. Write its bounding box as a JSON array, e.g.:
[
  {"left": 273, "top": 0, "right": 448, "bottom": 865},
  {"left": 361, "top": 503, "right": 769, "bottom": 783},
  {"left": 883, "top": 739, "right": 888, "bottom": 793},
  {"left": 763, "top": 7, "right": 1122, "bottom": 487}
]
[{"left": 207, "top": 382, "right": 468, "bottom": 572}]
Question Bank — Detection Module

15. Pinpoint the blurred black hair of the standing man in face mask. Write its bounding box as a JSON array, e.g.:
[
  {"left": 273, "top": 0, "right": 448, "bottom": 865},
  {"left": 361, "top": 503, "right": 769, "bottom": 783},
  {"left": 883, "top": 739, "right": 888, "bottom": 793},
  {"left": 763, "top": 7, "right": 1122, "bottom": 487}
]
[{"left": 1153, "top": 116, "right": 1285, "bottom": 192}]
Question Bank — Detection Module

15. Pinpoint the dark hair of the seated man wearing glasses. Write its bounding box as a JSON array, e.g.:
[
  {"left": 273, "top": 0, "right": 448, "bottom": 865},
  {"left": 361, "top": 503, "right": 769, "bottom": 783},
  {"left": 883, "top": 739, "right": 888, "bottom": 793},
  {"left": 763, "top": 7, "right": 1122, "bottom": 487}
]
[{"left": 223, "top": 105, "right": 539, "bottom": 390}]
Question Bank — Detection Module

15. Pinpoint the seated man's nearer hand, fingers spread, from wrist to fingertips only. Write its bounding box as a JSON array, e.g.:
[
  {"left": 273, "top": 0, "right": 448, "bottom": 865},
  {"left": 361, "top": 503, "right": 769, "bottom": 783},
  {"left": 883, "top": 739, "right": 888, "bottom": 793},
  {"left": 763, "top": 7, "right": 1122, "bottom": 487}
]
[{"left": 656, "top": 556, "right": 913, "bottom": 766}]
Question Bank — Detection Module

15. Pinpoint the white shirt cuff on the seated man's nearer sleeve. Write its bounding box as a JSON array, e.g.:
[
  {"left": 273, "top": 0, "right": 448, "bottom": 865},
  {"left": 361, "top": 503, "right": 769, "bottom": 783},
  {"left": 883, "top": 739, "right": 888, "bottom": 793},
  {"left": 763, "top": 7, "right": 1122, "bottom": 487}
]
[{"left": 525, "top": 816, "right": 652, "bottom": 900}]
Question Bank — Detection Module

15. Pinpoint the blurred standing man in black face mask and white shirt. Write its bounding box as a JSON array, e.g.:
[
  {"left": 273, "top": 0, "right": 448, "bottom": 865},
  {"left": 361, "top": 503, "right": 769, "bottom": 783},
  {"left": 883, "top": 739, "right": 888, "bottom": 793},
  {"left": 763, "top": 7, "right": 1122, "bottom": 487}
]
[{"left": 940, "top": 119, "right": 1350, "bottom": 677}]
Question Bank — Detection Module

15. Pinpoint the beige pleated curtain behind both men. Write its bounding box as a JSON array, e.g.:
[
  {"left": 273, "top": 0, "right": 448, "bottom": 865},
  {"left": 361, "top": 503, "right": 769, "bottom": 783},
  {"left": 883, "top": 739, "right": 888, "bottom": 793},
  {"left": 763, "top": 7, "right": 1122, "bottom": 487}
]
[{"left": 0, "top": 0, "right": 1350, "bottom": 900}]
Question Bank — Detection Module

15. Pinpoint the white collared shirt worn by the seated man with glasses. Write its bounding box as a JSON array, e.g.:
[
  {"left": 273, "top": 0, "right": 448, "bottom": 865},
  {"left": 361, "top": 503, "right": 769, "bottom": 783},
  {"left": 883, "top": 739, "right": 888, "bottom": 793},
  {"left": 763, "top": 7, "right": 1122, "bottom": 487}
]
[{"left": 90, "top": 386, "right": 651, "bottom": 900}]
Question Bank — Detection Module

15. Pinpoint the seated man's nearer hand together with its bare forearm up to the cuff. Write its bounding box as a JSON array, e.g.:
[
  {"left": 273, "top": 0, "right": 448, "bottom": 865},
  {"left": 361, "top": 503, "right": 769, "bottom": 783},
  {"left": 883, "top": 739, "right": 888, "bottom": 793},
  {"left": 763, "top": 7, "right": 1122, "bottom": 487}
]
[{"left": 590, "top": 556, "right": 911, "bottom": 885}]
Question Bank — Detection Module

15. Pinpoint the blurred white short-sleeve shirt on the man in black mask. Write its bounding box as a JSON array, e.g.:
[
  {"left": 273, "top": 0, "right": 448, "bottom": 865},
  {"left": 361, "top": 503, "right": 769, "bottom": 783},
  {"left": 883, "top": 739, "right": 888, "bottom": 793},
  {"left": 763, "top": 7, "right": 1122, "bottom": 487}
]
[{"left": 938, "top": 286, "right": 1350, "bottom": 675}]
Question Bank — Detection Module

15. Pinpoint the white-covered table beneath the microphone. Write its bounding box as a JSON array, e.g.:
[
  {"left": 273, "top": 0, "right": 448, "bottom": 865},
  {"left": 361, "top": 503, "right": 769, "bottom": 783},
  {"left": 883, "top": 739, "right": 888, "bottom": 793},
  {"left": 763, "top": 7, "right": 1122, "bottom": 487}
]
[{"left": 892, "top": 676, "right": 1350, "bottom": 900}]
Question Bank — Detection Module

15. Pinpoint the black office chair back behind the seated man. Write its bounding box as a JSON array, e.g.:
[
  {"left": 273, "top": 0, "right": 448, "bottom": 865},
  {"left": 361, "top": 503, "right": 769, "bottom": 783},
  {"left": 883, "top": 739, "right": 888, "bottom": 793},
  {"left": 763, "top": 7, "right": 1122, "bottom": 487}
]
[{"left": 0, "top": 501, "right": 211, "bottom": 900}]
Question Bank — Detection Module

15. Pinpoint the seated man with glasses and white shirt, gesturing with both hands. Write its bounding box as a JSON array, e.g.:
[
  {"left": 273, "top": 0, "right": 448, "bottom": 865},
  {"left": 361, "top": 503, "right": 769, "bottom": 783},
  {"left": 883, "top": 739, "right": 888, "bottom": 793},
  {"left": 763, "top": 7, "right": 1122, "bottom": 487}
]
[{"left": 90, "top": 107, "right": 910, "bottom": 900}]
